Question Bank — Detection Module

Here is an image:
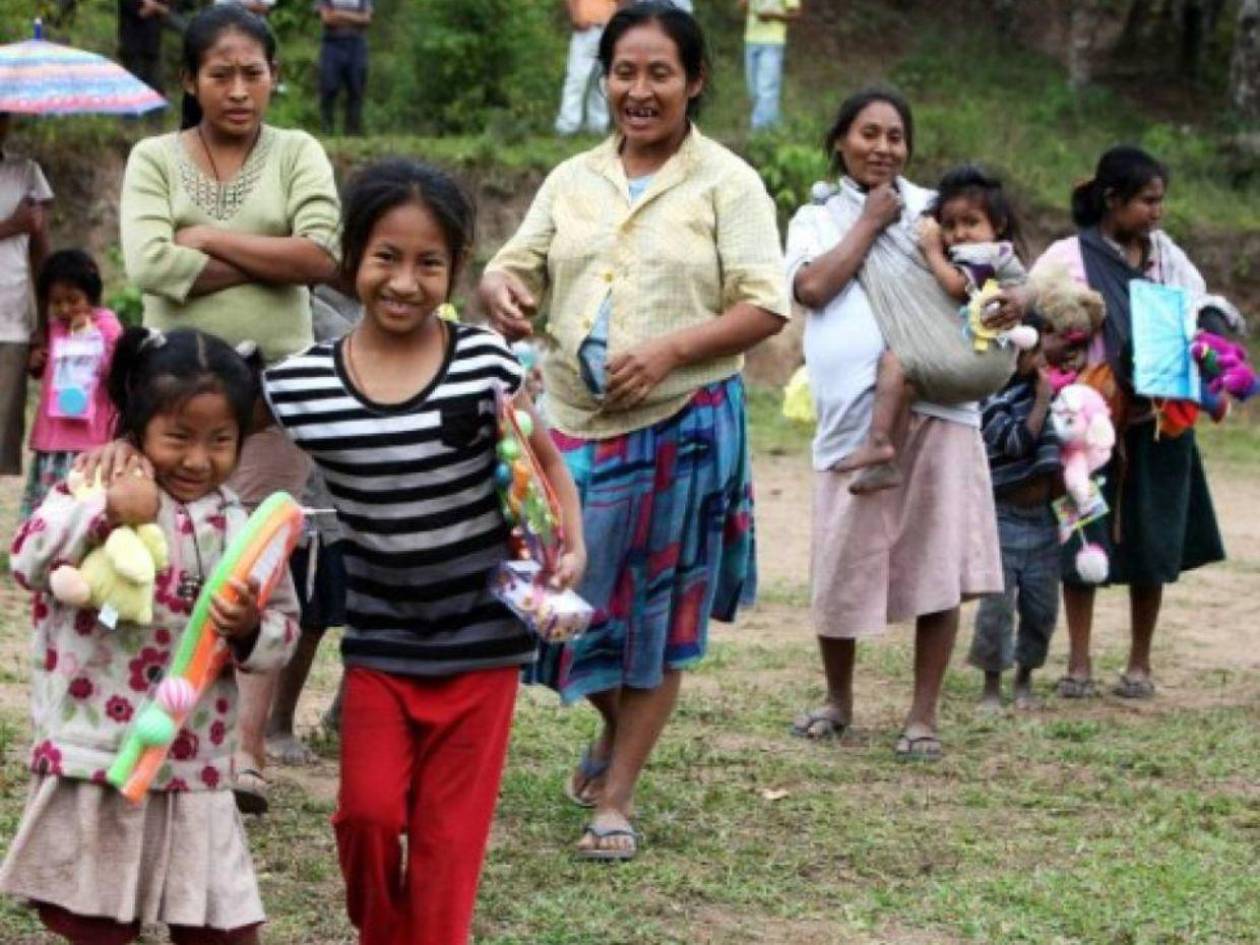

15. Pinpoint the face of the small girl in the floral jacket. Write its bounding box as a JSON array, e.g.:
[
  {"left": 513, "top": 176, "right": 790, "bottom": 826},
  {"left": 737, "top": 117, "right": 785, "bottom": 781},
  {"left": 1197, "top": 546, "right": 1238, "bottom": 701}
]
[{"left": 140, "top": 391, "right": 241, "bottom": 501}]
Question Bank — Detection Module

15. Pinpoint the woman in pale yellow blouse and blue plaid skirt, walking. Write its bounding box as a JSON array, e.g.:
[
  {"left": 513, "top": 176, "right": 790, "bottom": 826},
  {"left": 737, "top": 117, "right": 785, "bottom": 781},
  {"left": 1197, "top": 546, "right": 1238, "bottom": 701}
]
[{"left": 480, "top": 3, "right": 789, "bottom": 859}]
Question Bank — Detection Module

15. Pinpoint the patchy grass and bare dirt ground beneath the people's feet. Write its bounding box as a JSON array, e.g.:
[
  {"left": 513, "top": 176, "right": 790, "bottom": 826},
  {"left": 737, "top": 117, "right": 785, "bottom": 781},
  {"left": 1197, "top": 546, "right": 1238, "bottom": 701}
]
[{"left": 0, "top": 392, "right": 1260, "bottom": 945}]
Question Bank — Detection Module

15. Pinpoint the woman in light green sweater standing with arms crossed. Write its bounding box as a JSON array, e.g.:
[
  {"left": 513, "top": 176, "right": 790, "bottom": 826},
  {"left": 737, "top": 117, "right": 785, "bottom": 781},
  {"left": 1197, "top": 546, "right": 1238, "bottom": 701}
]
[{"left": 121, "top": 4, "right": 339, "bottom": 813}]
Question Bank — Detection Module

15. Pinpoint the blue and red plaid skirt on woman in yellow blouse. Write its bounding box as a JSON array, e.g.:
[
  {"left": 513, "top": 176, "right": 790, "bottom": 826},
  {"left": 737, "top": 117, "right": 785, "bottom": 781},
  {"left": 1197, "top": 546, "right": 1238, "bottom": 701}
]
[{"left": 525, "top": 375, "right": 756, "bottom": 702}]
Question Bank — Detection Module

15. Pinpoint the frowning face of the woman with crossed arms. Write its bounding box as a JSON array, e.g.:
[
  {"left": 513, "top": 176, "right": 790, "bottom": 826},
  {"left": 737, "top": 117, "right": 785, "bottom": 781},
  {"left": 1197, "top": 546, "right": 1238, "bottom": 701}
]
[{"left": 184, "top": 28, "right": 276, "bottom": 137}]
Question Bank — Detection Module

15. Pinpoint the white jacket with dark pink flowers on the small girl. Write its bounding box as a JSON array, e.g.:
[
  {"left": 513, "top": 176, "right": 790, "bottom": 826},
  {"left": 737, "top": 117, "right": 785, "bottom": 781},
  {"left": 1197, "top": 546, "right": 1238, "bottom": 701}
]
[{"left": 10, "top": 484, "right": 297, "bottom": 791}]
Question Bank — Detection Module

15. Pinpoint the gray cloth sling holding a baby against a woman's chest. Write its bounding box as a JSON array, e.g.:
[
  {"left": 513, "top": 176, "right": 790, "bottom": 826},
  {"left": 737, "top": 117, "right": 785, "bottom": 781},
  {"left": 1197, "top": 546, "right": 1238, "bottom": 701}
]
[{"left": 827, "top": 178, "right": 1017, "bottom": 404}]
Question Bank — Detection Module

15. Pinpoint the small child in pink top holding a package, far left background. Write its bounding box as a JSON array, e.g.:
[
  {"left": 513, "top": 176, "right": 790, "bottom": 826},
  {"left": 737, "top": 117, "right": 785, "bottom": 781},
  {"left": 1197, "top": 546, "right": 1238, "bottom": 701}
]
[{"left": 21, "top": 249, "right": 122, "bottom": 519}]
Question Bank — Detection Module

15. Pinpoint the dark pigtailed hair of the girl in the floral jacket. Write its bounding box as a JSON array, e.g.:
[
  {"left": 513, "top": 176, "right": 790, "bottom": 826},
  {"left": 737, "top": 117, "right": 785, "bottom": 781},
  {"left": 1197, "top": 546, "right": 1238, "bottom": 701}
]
[{"left": 108, "top": 328, "right": 261, "bottom": 446}]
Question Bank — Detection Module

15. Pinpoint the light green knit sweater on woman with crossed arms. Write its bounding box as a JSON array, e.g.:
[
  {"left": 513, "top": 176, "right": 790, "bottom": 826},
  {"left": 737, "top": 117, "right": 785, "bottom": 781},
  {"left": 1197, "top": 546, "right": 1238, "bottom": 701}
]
[{"left": 121, "top": 126, "right": 339, "bottom": 364}]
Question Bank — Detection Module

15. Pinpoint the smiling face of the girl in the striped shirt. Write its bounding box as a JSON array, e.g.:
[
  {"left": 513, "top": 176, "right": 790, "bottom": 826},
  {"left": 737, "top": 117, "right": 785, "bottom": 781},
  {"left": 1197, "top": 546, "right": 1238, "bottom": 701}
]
[{"left": 354, "top": 200, "right": 457, "bottom": 335}]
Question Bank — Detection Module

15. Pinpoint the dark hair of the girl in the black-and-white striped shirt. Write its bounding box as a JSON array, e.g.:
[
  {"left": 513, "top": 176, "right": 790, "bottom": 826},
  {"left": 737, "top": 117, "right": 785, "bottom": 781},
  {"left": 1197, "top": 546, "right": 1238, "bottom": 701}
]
[{"left": 341, "top": 158, "right": 476, "bottom": 294}]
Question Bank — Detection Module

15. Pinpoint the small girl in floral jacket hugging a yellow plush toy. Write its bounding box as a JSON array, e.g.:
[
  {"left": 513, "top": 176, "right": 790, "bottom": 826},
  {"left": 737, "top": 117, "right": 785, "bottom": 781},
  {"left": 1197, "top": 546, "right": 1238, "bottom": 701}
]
[{"left": 0, "top": 329, "right": 297, "bottom": 945}]
